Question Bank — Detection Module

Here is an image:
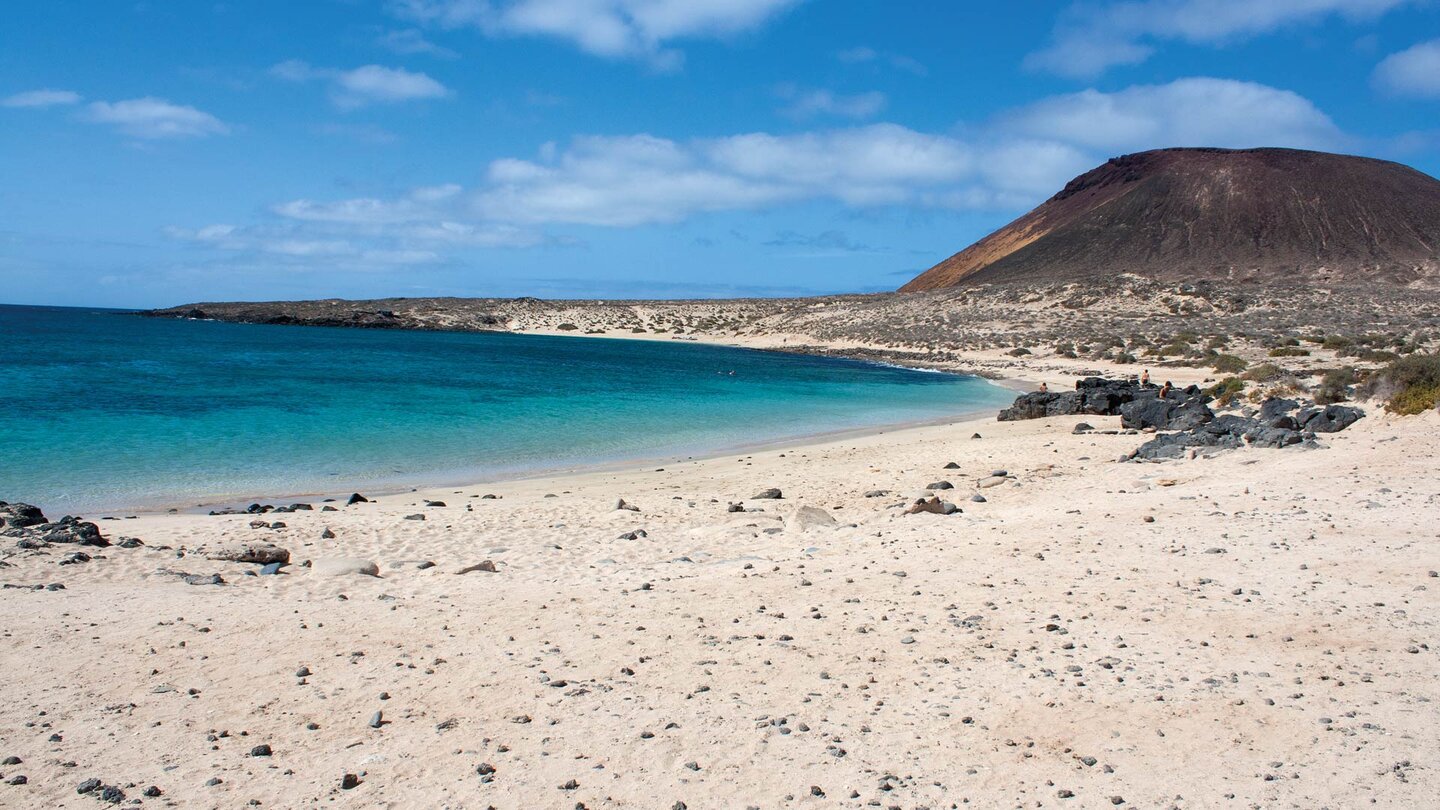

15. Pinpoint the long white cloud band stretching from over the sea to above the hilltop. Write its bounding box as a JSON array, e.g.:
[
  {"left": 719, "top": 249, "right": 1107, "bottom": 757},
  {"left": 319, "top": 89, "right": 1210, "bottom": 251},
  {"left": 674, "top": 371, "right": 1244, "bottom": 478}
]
[{"left": 177, "top": 78, "right": 1348, "bottom": 268}]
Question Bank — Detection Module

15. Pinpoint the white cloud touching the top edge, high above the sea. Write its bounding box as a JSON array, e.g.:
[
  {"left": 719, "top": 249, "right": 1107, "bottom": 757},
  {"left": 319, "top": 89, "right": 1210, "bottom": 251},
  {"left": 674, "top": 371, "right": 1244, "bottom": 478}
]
[{"left": 392, "top": 0, "right": 802, "bottom": 66}]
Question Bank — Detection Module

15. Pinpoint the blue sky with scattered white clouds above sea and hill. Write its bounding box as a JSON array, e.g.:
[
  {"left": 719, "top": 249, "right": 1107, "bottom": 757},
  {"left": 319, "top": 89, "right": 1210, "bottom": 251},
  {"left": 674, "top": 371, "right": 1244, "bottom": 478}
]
[{"left": 0, "top": 0, "right": 1440, "bottom": 307}]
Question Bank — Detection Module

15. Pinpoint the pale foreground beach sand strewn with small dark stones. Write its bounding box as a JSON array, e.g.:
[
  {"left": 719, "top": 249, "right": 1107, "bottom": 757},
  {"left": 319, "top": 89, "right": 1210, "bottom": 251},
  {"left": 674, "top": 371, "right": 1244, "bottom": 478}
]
[{"left": 0, "top": 379, "right": 1440, "bottom": 809}]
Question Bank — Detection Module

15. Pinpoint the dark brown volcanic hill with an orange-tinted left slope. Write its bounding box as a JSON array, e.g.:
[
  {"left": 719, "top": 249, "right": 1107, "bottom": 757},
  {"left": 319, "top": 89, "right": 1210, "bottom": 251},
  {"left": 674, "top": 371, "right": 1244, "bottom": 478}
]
[{"left": 900, "top": 148, "right": 1440, "bottom": 293}]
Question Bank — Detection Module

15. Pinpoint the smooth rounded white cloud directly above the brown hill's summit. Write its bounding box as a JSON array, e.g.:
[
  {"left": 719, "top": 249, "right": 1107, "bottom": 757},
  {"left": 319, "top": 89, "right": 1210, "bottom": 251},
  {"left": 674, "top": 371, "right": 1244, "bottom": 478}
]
[{"left": 1004, "top": 78, "right": 1345, "bottom": 151}]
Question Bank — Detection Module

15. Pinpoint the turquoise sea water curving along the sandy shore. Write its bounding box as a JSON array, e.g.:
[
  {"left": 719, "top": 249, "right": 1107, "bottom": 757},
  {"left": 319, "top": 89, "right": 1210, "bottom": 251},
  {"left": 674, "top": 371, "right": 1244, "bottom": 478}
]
[{"left": 0, "top": 306, "right": 1012, "bottom": 513}]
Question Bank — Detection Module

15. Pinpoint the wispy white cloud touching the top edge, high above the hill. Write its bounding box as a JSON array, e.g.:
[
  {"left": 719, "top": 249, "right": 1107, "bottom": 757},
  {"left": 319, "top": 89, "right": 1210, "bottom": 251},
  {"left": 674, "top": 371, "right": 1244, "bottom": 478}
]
[{"left": 1025, "top": 0, "right": 1414, "bottom": 78}]
